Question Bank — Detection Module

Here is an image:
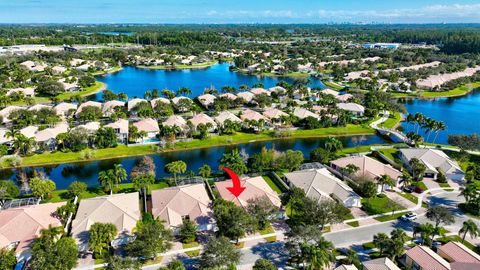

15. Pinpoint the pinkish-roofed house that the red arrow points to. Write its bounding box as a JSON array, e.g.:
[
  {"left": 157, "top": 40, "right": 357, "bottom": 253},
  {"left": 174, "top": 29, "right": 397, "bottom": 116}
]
[{"left": 215, "top": 176, "right": 282, "bottom": 207}]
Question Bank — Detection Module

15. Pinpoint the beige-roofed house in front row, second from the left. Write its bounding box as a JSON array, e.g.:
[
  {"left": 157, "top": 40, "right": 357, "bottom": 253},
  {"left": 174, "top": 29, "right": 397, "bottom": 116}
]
[{"left": 71, "top": 192, "right": 142, "bottom": 251}]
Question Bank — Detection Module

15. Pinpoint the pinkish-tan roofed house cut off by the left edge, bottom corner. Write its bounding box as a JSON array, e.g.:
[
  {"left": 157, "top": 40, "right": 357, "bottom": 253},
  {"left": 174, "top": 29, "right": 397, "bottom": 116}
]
[{"left": 0, "top": 202, "right": 65, "bottom": 260}]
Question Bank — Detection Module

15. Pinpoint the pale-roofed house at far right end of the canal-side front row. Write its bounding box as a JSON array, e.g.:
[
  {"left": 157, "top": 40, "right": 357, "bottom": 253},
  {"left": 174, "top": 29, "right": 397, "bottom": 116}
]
[{"left": 399, "top": 148, "right": 465, "bottom": 181}]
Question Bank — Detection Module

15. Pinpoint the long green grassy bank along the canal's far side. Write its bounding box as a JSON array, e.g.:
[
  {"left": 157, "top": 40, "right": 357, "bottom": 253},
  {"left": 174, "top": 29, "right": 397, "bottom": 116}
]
[{"left": 0, "top": 125, "right": 374, "bottom": 167}]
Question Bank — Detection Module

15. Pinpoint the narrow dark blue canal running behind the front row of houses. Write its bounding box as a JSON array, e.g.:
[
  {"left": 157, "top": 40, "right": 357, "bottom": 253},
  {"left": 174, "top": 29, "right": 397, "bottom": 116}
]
[{"left": 0, "top": 135, "right": 385, "bottom": 189}]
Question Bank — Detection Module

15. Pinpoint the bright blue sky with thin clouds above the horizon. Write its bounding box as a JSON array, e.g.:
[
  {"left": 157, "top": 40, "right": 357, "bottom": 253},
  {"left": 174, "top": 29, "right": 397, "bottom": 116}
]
[{"left": 0, "top": 0, "right": 480, "bottom": 24}]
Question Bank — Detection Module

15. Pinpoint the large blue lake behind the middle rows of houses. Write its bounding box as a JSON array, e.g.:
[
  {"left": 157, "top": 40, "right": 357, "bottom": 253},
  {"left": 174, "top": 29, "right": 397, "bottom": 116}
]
[{"left": 96, "top": 62, "right": 325, "bottom": 99}]
